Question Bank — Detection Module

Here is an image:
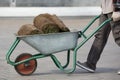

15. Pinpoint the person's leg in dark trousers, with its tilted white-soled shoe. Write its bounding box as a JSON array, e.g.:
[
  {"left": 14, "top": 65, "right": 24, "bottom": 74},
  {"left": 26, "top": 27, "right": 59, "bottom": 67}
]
[{"left": 78, "top": 14, "right": 111, "bottom": 72}]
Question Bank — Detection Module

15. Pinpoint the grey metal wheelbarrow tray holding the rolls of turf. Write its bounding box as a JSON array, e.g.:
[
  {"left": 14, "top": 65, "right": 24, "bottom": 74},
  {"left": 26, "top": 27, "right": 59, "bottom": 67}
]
[{"left": 17, "top": 32, "right": 79, "bottom": 54}]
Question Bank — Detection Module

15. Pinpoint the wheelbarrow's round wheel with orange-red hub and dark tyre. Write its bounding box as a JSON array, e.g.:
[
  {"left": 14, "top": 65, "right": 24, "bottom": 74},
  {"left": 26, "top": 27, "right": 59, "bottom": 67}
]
[{"left": 14, "top": 53, "right": 37, "bottom": 76}]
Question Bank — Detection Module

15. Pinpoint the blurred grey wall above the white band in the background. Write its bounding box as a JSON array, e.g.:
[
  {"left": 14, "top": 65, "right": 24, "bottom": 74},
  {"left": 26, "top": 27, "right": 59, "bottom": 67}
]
[{"left": 0, "top": 0, "right": 100, "bottom": 7}]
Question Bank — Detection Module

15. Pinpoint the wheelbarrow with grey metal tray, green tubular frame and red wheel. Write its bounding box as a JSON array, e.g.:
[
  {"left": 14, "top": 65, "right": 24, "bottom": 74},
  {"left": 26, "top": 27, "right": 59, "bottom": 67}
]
[{"left": 6, "top": 16, "right": 112, "bottom": 76}]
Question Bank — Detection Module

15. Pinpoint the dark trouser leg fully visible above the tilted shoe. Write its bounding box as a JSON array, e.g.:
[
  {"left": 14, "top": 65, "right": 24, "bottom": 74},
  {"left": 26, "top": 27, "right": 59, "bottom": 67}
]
[{"left": 87, "top": 13, "right": 119, "bottom": 70}]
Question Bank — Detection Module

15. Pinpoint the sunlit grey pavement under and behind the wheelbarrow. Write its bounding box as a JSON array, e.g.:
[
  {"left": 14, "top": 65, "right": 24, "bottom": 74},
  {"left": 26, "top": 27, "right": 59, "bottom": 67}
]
[{"left": 0, "top": 17, "right": 120, "bottom": 80}]
